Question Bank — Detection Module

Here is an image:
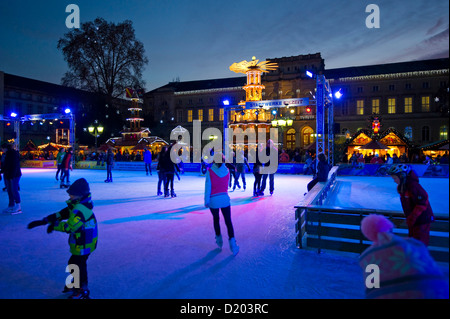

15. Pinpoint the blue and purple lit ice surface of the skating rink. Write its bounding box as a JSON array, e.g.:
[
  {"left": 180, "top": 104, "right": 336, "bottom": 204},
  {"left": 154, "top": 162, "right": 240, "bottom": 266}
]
[{"left": 0, "top": 169, "right": 449, "bottom": 299}]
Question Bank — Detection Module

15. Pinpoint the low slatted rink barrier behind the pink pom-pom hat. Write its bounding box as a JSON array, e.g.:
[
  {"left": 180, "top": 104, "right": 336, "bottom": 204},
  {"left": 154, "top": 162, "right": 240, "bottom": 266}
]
[{"left": 296, "top": 204, "right": 449, "bottom": 263}]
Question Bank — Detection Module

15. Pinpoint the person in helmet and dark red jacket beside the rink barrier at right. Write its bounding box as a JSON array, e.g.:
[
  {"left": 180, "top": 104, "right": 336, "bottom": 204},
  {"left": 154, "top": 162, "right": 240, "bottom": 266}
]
[{"left": 388, "top": 164, "right": 434, "bottom": 246}]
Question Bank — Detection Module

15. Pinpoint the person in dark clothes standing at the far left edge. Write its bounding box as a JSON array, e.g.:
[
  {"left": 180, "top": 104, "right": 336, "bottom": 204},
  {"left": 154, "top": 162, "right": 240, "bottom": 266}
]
[{"left": 1, "top": 143, "right": 22, "bottom": 215}]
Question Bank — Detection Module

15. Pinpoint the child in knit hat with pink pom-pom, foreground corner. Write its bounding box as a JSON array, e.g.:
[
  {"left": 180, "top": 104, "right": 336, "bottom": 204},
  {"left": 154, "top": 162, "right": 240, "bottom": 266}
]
[{"left": 359, "top": 214, "right": 448, "bottom": 299}]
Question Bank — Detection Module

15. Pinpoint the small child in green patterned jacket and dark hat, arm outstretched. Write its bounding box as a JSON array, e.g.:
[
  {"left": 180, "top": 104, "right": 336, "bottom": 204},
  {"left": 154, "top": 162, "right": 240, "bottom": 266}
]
[{"left": 28, "top": 178, "right": 98, "bottom": 299}]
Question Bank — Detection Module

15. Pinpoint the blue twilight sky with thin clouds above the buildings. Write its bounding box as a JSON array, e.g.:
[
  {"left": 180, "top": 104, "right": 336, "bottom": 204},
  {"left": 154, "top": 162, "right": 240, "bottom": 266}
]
[{"left": 0, "top": 0, "right": 449, "bottom": 90}]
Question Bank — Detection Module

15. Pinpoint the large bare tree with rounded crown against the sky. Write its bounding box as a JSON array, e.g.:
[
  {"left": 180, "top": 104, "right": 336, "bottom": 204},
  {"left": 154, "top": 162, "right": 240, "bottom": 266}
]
[{"left": 58, "top": 18, "right": 148, "bottom": 100}]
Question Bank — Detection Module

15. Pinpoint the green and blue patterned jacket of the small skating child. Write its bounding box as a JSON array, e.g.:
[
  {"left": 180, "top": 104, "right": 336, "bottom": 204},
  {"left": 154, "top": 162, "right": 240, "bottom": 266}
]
[{"left": 47, "top": 194, "right": 98, "bottom": 255}]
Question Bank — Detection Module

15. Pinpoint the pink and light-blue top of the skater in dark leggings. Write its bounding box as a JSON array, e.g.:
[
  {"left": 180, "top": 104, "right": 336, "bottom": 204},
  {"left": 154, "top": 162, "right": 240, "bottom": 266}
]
[{"left": 205, "top": 164, "right": 230, "bottom": 208}]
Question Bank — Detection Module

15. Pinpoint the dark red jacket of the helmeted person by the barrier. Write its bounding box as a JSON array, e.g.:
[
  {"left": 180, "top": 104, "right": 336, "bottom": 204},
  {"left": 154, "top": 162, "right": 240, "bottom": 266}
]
[{"left": 400, "top": 171, "right": 434, "bottom": 226}]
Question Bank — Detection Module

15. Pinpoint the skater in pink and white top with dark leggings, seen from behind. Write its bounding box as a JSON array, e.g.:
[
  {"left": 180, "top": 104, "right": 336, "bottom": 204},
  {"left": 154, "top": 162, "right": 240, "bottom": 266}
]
[{"left": 205, "top": 157, "right": 239, "bottom": 256}]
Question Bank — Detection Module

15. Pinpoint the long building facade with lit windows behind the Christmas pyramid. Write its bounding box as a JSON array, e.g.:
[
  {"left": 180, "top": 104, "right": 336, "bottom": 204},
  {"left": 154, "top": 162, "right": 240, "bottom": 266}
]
[{"left": 144, "top": 53, "right": 449, "bottom": 156}]
